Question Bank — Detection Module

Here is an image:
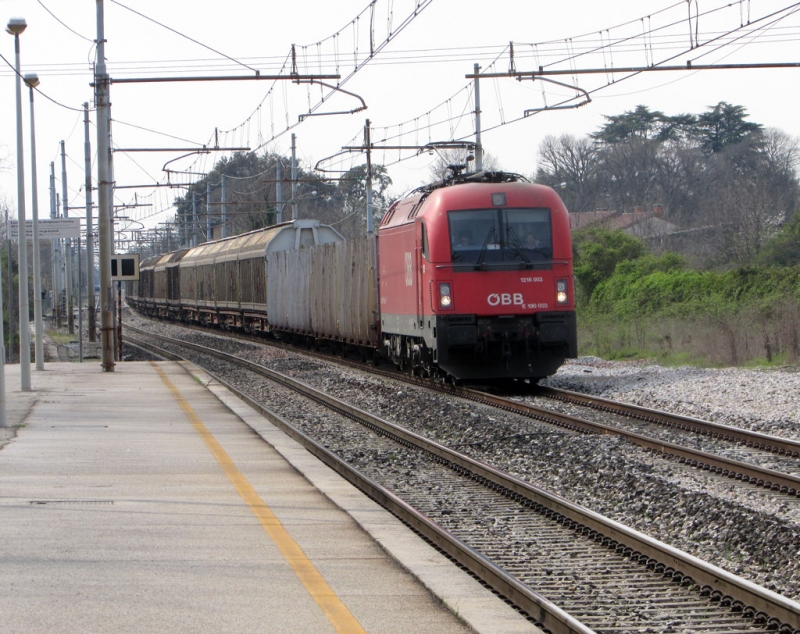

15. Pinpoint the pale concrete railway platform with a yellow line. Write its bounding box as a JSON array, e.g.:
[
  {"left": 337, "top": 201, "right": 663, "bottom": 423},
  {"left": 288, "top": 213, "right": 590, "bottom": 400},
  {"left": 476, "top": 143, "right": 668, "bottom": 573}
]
[{"left": 0, "top": 362, "right": 539, "bottom": 634}]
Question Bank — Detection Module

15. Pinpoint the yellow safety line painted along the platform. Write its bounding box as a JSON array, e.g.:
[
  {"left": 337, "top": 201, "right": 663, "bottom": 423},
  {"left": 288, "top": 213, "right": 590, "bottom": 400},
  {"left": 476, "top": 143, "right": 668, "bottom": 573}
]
[{"left": 153, "top": 363, "right": 366, "bottom": 634}]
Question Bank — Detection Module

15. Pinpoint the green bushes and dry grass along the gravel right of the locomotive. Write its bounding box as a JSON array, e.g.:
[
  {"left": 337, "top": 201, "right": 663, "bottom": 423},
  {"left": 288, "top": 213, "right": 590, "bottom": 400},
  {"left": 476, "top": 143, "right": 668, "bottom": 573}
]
[{"left": 574, "top": 227, "right": 800, "bottom": 365}]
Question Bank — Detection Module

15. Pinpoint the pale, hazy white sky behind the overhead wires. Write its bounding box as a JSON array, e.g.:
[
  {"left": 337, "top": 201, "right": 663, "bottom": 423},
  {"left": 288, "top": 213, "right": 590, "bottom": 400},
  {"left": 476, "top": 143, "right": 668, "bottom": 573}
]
[{"left": 0, "top": 0, "right": 800, "bottom": 233}]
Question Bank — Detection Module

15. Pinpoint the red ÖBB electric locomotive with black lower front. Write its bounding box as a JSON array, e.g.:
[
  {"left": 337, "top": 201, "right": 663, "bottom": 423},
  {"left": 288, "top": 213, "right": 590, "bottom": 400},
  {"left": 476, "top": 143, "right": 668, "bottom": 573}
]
[{"left": 378, "top": 172, "right": 577, "bottom": 381}]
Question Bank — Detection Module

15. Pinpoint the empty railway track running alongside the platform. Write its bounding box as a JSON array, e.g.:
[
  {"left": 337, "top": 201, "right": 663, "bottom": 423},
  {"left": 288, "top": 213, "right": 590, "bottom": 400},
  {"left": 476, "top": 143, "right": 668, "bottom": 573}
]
[{"left": 122, "top": 328, "right": 800, "bottom": 633}]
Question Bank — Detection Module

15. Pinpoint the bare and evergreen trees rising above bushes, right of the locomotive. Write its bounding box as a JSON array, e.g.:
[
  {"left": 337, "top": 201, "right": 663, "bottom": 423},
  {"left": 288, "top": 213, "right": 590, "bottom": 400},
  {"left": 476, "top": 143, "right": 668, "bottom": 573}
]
[{"left": 536, "top": 102, "right": 800, "bottom": 266}]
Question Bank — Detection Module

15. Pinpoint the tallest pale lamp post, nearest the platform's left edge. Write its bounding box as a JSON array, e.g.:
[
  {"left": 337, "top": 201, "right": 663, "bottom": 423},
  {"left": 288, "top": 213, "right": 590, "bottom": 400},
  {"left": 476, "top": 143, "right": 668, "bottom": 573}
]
[{"left": 6, "top": 18, "right": 31, "bottom": 392}]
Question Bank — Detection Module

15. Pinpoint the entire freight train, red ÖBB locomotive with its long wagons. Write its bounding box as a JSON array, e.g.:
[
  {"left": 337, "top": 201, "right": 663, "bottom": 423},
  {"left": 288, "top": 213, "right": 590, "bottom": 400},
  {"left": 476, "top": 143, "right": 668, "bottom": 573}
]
[{"left": 127, "top": 172, "right": 577, "bottom": 382}]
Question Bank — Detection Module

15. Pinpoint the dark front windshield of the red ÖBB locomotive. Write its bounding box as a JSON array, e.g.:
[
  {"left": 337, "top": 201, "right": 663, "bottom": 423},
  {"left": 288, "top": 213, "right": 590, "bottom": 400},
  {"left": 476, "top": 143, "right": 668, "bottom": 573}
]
[{"left": 448, "top": 207, "right": 553, "bottom": 266}]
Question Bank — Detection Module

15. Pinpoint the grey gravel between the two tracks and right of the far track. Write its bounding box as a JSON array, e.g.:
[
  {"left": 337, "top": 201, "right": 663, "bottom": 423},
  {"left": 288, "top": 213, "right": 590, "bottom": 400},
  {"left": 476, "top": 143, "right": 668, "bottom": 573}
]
[{"left": 119, "top": 322, "right": 800, "bottom": 601}]
